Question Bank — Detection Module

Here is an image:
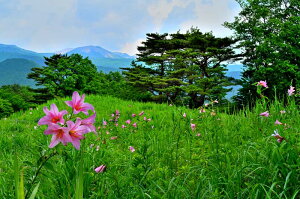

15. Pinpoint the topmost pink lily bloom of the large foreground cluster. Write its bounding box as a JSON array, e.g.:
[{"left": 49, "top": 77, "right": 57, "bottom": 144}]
[{"left": 66, "top": 91, "right": 95, "bottom": 115}]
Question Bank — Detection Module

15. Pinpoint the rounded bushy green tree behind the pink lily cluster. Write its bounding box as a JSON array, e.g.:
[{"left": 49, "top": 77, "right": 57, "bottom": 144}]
[{"left": 28, "top": 54, "right": 97, "bottom": 98}]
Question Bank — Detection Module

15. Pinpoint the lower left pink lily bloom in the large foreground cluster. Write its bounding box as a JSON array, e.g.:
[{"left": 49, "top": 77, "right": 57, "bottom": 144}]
[{"left": 44, "top": 124, "right": 72, "bottom": 148}]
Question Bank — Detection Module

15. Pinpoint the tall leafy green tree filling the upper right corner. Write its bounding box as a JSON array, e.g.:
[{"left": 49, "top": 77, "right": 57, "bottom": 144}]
[{"left": 225, "top": 0, "right": 300, "bottom": 104}]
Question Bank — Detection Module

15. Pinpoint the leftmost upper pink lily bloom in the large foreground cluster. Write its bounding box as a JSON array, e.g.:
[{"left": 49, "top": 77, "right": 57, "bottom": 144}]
[{"left": 38, "top": 104, "right": 68, "bottom": 125}]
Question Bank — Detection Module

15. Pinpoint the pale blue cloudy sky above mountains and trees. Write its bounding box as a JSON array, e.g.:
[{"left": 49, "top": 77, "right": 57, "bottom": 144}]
[{"left": 0, "top": 0, "right": 240, "bottom": 54}]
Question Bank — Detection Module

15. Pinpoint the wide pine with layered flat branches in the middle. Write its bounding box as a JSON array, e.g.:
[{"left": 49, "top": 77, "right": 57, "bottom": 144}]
[{"left": 124, "top": 28, "right": 237, "bottom": 107}]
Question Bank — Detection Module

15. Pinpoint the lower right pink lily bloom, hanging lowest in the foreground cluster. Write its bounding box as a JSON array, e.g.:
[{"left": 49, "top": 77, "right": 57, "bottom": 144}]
[{"left": 65, "top": 118, "right": 90, "bottom": 150}]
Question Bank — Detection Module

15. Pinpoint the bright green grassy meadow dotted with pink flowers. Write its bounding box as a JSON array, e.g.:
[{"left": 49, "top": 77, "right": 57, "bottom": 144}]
[{"left": 0, "top": 96, "right": 300, "bottom": 199}]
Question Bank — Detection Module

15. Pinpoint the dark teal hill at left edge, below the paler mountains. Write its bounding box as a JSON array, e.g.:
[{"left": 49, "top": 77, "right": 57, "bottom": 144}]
[{"left": 0, "top": 58, "right": 39, "bottom": 87}]
